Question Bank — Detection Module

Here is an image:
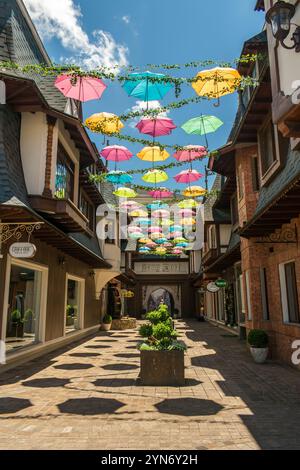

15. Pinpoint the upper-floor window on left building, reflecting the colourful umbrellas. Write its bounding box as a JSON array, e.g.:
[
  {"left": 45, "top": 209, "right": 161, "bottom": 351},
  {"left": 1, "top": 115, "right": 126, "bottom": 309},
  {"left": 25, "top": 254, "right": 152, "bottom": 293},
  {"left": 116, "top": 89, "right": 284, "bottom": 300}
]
[{"left": 55, "top": 143, "right": 75, "bottom": 201}]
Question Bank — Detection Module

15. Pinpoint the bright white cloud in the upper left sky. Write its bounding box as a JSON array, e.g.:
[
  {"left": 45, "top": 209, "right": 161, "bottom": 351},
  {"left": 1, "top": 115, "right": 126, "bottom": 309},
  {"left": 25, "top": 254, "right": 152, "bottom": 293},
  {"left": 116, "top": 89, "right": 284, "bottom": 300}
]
[{"left": 24, "top": 0, "right": 128, "bottom": 68}]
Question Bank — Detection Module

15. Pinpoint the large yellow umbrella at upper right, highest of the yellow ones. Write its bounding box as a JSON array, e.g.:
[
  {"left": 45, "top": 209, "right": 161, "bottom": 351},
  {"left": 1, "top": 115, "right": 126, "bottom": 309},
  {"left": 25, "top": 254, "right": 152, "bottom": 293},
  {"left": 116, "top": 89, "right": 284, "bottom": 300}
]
[{"left": 192, "top": 67, "right": 242, "bottom": 105}]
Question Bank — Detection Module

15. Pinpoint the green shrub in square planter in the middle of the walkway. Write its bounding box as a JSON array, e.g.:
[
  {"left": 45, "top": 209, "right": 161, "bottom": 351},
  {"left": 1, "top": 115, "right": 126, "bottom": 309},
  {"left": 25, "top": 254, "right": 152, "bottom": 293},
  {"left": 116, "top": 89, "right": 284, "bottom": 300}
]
[{"left": 139, "top": 304, "right": 186, "bottom": 386}]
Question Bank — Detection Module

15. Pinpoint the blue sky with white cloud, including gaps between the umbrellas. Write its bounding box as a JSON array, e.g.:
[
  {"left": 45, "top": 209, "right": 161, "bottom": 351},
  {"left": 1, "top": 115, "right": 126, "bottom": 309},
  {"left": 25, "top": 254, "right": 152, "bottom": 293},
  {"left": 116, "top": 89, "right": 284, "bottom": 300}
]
[{"left": 25, "top": 0, "right": 264, "bottom": 189}]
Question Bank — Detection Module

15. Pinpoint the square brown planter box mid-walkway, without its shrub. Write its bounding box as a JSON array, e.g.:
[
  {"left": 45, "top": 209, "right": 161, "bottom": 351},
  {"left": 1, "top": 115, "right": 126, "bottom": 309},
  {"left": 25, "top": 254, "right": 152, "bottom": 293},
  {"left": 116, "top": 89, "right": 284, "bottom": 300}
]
[{"left": 140, "top": 351, "right": 185, "bottom": 386}]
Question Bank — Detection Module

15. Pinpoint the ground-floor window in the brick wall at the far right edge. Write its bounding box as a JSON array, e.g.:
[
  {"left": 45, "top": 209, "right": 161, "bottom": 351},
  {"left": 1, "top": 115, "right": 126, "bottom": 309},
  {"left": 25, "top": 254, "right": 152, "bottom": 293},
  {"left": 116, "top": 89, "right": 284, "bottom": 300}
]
[{"left": 279, "top": 261, "right": 300, "bottom": 323}]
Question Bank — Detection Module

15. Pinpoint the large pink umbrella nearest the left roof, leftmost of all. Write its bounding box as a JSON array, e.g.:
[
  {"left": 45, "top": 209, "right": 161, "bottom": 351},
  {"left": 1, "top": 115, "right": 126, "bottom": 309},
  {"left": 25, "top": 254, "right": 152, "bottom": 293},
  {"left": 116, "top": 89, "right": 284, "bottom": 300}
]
[{"left": 55, "top": 74, "right": 107, "bottom": 102}]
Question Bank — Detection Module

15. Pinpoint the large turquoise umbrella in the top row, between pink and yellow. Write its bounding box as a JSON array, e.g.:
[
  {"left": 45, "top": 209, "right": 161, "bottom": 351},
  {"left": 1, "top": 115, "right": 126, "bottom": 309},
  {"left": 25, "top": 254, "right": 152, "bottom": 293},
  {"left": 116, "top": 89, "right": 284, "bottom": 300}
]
[{"left": 123, "top": 72, "right": 172, "bottom": 101}]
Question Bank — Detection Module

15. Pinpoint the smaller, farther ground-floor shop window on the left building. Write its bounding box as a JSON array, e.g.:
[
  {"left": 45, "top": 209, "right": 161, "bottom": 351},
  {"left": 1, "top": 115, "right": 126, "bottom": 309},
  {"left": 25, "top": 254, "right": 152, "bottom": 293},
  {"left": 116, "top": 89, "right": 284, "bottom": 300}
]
[{"left": 65, "top": 276, "right": 84, "bottom": 334}]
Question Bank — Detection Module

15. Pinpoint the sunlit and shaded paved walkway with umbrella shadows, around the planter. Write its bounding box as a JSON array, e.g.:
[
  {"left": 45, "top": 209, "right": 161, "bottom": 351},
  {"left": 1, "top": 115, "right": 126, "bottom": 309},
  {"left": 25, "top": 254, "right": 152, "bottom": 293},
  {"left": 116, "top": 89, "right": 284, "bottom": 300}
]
[{"left": 0, "top": 321, "right": 300, "bottom": 450}]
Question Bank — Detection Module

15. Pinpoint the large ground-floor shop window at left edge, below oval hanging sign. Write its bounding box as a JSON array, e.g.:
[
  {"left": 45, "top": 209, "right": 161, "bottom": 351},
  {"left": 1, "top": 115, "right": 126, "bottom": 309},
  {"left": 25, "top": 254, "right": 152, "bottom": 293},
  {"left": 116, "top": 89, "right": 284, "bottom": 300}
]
[{"left": 5, "top": 263, "right": 47, "bottom": 352}]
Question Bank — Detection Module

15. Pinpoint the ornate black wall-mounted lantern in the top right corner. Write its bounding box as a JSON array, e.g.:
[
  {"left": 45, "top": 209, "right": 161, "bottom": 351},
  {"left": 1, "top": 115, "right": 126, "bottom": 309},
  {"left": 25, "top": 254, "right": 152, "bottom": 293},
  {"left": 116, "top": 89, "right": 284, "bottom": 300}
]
[{"left": 266, "top": 1, "right": 300, "bottom": 52}]
